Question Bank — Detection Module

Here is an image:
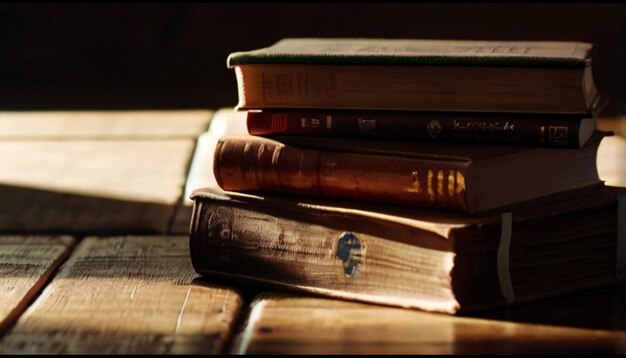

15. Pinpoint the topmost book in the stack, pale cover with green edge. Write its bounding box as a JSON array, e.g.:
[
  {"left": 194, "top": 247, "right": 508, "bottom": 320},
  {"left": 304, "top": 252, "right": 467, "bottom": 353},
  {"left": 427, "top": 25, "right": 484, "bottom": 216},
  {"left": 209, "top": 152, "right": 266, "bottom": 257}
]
[{"left": 227, "top": 38, "right": 600, "bottom": 113}]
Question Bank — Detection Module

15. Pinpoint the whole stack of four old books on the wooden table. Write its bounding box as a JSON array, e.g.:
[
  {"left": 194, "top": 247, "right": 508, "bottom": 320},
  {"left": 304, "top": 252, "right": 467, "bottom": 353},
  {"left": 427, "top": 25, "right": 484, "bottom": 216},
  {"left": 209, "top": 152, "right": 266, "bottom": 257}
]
[{"left": 190, "top": 39, "right": 626, "bottom": 313}]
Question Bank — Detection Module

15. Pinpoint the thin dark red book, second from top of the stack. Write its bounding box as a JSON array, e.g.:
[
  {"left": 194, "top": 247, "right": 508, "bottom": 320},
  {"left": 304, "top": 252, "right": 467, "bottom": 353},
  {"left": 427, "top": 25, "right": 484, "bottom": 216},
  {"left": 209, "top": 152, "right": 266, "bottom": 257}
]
[{"left": 247, "top": 109, "right": 596, "bottom": 148}]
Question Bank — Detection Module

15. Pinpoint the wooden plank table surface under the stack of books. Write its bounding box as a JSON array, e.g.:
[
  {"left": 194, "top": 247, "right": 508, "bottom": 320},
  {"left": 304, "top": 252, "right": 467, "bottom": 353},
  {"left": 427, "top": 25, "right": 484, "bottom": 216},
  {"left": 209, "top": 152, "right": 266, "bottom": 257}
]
[{"left": 0, "top": 110, "right": 626, "bottom": 354}]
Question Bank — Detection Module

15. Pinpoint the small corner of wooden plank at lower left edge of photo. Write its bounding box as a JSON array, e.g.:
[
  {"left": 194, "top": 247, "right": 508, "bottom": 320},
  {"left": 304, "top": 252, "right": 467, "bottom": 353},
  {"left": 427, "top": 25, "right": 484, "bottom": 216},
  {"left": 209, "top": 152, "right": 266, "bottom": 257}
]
[{"left": 0, "top": 236, "right": 75, "bottom": 332}]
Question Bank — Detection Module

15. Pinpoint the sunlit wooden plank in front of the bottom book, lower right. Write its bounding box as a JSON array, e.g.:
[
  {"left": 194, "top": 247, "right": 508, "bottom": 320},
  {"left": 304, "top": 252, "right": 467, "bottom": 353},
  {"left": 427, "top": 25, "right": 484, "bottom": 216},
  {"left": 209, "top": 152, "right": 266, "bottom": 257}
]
[{"left": 232, "top": 294, "right": 626, "bottom": 354}]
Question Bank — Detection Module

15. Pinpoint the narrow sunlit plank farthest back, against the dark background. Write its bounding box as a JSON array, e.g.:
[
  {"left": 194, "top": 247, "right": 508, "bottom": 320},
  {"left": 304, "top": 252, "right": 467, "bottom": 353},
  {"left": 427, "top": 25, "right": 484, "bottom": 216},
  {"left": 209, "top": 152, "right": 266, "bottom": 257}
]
[{"left": 0, "top": 109, "right": 212, "bottom": 140}]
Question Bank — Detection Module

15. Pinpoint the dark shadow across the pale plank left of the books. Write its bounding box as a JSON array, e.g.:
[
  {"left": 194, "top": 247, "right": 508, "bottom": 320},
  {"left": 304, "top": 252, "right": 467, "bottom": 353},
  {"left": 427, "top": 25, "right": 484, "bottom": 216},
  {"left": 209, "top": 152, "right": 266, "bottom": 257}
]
[{"left": 0, "top": 184, "right": 176, "bottom": 236}]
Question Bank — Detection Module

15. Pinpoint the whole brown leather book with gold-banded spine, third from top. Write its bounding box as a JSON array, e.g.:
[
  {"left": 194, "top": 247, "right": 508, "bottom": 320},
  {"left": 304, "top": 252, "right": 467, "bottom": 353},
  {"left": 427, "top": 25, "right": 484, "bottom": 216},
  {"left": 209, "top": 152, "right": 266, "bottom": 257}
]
[{"left": 213, "top": 131, "right": 605, "bottom": 213}]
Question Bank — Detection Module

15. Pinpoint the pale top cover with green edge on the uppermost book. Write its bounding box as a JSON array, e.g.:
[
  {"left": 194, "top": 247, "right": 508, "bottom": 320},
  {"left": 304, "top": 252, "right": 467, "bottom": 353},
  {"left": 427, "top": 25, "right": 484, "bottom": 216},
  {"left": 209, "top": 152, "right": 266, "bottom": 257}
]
[{"left": 227, "top": 38, "right": 596, "bottom": 68}]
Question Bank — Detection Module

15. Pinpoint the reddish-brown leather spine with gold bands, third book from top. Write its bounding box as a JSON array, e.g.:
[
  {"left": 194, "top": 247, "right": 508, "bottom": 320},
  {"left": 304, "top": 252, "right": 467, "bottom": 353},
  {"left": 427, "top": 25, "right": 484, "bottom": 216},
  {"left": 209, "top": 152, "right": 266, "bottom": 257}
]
[{"left": 213, "top": 136, "right": 469, "bottom": 211}]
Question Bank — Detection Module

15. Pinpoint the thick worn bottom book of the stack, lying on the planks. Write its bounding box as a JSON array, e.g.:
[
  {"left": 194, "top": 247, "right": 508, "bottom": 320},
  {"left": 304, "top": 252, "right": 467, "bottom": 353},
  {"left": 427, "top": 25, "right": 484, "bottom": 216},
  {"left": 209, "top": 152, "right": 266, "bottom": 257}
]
[{"left": 190, "top": 185, "right": 626, "bottom": 313}]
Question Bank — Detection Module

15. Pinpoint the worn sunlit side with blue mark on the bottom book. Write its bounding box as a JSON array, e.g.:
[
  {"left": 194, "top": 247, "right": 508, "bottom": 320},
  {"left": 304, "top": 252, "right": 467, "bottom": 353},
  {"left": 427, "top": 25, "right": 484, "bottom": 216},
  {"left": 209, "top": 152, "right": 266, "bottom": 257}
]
[{"left": 189, "top": 199, "right": 459, "bottom": 313}]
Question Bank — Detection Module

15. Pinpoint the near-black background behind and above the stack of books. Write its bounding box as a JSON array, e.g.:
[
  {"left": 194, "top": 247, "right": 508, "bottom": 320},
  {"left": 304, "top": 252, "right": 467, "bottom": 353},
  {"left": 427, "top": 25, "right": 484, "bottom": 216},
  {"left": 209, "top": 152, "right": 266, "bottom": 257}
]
[{"left": 0, "top": 3, "right": 626, "bottom": 113}]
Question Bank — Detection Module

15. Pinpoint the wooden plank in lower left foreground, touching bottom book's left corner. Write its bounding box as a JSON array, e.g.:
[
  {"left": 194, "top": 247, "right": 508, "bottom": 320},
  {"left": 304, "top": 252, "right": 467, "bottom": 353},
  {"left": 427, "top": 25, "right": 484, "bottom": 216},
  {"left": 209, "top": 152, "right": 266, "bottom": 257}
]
[{"left": 0, "top": 236, "right": 242, "bottom": 354}]
